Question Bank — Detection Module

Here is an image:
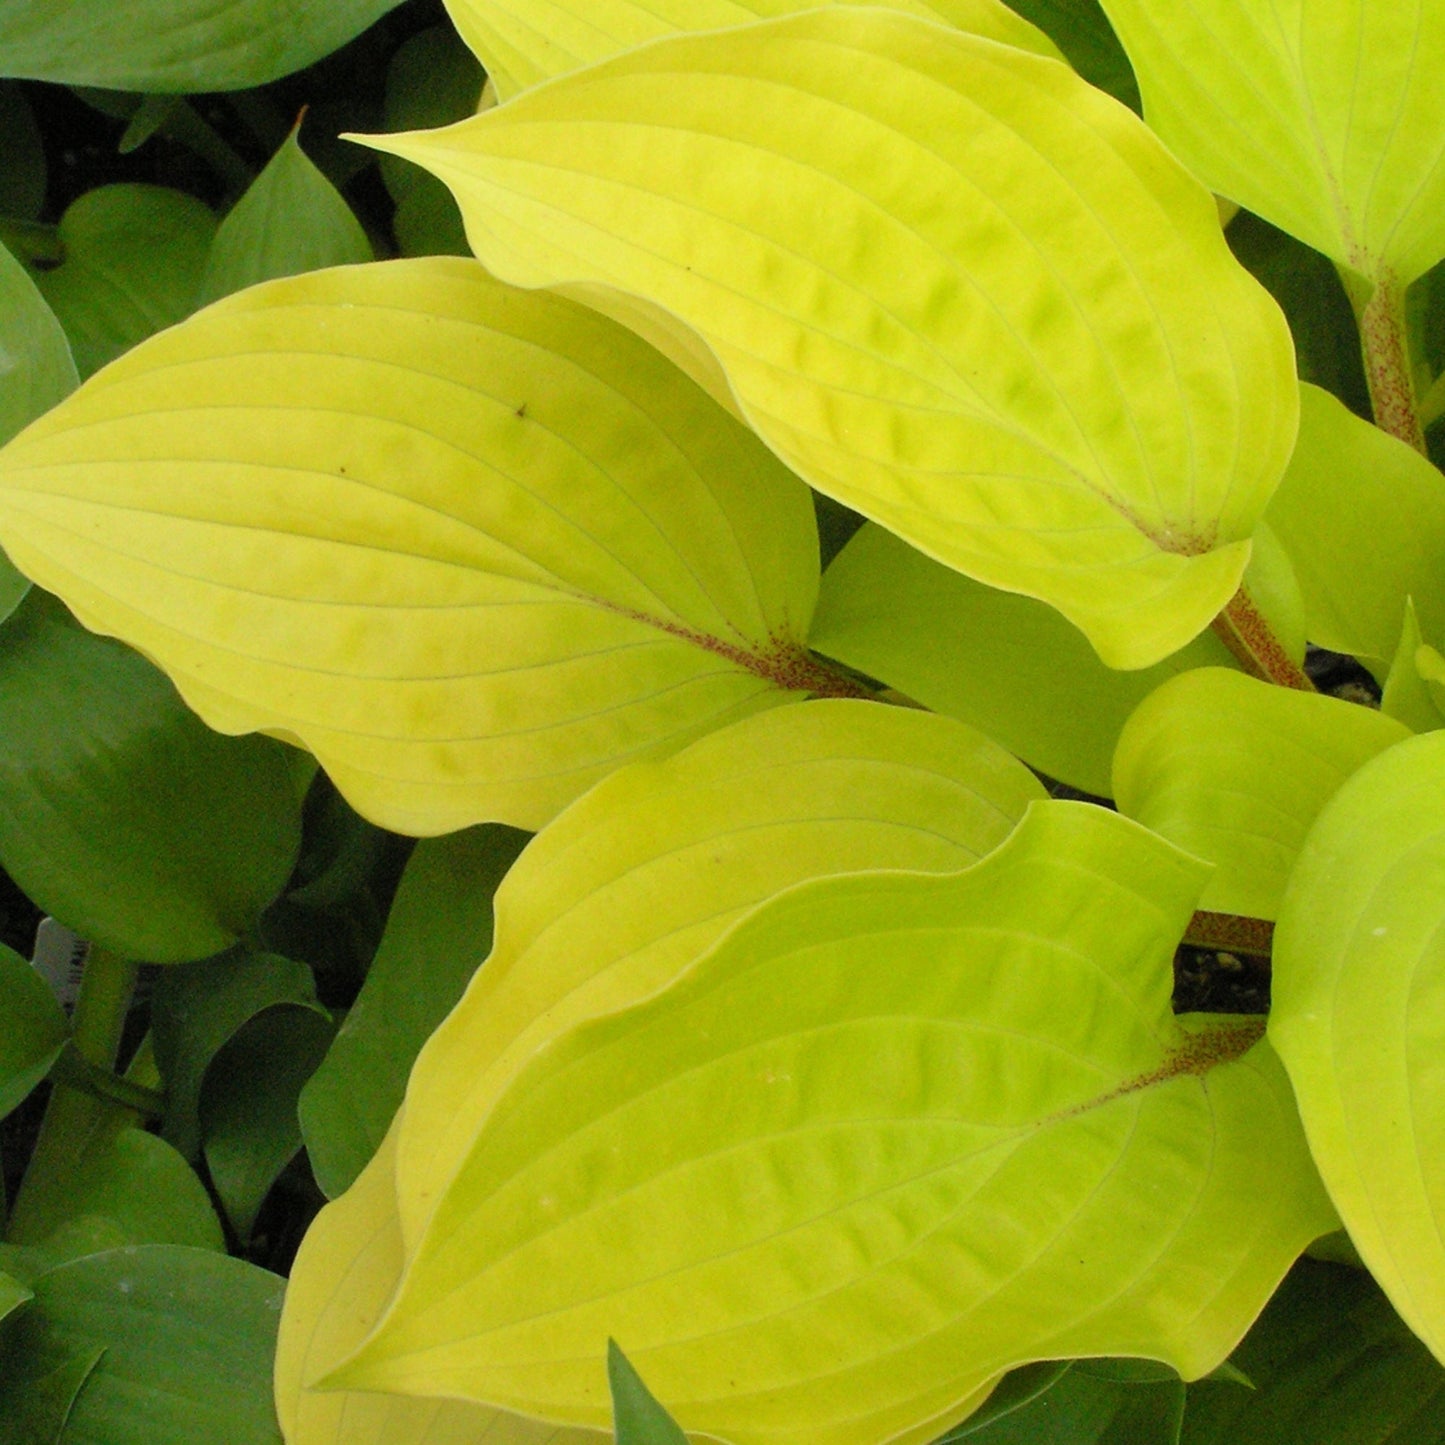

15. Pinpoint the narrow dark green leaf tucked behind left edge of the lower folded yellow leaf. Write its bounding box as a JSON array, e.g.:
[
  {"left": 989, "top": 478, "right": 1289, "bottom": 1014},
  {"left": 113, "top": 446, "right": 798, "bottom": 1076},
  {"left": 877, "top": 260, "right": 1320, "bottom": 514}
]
[{"left": 301, "top": 825, "right": 526, "bottom": 1198}]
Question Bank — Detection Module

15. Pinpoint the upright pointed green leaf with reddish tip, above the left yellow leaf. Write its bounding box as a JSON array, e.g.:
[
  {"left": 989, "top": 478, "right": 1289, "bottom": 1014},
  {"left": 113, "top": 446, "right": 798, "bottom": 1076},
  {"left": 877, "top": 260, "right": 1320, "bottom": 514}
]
[{"left": 197, "top": 127, "right": 373, "bottom": 305}]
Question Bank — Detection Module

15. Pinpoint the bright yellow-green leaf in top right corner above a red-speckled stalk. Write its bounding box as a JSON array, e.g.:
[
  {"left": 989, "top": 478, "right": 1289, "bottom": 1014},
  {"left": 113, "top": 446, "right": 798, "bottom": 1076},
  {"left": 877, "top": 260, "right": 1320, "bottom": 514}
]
[{"left": 1103, "top": 0, "right": 1445, "bottom": 286}]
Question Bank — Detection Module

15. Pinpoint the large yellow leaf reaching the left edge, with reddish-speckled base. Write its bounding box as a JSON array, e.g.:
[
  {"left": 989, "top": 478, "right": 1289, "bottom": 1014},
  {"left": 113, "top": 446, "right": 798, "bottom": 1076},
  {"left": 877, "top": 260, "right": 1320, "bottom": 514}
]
[{"left": 0, "top": 257, "right": 851, "bottom": 832}]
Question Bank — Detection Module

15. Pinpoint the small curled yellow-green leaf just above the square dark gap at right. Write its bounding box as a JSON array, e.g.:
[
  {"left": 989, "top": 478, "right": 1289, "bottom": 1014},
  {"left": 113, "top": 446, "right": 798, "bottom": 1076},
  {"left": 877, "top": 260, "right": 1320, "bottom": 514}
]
[{"left": 1113, "top": 668, "right": 1409, "bottom": 919}]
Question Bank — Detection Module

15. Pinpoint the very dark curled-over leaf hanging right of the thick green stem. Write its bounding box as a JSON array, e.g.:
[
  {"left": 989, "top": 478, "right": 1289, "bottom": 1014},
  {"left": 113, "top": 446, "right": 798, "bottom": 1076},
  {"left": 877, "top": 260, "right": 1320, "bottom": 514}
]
[{"left": 201, "top": 1009, "right": 335, "bottom": 1240}]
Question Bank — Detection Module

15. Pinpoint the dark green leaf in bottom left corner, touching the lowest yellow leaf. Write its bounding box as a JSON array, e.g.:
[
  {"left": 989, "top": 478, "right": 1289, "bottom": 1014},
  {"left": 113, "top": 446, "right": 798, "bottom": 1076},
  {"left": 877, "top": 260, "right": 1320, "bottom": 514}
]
[{"left": 0, "top": 1244, "right": 283, "bottom": 1445}]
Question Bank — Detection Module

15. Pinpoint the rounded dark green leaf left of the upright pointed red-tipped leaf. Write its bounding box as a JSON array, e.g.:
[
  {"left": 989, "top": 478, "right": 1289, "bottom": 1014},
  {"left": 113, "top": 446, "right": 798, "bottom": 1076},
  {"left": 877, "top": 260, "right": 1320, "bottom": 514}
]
[{"left": 31, "top": 184, "right": 215, "bottom": 377}]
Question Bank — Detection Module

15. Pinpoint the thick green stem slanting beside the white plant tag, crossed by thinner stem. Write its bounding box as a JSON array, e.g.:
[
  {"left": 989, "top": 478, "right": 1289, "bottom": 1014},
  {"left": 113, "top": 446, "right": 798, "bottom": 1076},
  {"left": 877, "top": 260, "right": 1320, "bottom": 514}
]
[{"left": 6, "top": 948, "right": 139, "bottom": 1244}]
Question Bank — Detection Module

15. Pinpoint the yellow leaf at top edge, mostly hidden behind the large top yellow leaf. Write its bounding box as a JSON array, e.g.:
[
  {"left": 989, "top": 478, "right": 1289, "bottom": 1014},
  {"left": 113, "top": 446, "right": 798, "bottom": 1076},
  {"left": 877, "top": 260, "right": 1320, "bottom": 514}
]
[{"left": 447, "top": 0, "right": 1059, "bottom": 100}]
